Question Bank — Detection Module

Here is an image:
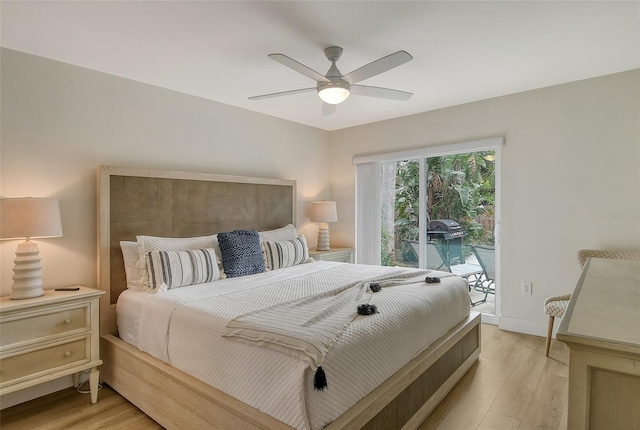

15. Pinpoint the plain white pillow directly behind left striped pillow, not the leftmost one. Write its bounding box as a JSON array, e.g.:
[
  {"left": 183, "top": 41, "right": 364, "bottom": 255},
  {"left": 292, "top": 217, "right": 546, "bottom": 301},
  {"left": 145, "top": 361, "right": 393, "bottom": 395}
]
[{"left": 136, "top": 234, "right": 222, "bottom": 287}]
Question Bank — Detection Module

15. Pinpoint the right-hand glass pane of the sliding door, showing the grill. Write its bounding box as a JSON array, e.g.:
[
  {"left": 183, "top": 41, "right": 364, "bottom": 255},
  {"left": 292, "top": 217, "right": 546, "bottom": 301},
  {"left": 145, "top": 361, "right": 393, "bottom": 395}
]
[{"left": 426, "top": 151, "right": 495, "bottom": 313}]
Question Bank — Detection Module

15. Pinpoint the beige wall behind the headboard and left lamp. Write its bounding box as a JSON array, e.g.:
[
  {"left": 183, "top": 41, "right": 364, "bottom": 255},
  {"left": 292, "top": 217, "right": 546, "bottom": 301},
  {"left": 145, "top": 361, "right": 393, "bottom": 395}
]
[{"left": 0, "top": 49, "right": 330, "bottom": 295}]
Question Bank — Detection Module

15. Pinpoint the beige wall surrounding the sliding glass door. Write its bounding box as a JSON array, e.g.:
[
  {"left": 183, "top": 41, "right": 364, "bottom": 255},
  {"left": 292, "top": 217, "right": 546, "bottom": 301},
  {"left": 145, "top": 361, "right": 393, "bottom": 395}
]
[{"left": 331, "top": 70, "right": 640, "bottom": 335}]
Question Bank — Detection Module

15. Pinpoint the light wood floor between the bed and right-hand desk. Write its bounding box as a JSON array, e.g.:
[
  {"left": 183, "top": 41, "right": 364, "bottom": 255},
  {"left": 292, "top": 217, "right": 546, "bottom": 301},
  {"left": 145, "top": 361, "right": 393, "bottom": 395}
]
[{"left": 420, "top": 324, "right": 569, "bottom": 430}]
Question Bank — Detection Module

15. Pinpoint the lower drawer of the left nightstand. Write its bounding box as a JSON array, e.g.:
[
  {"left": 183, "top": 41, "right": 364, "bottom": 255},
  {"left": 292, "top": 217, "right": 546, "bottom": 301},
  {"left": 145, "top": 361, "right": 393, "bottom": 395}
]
[{"left": 0, "top": 337, "right": 89, "bottom": 386}]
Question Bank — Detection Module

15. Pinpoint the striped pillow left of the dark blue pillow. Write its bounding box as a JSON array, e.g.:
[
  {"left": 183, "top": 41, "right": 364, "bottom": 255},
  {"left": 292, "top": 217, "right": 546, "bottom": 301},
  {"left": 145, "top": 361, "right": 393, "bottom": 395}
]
[{"left": 145, "top": 248, "right": 220, "bottom": 293}]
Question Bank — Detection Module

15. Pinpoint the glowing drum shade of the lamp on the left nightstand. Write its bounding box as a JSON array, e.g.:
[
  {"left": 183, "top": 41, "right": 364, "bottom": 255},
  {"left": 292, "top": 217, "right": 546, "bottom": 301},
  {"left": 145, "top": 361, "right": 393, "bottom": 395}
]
[{"left": 0, "top": 197, "right": 62, "bottom": 239}]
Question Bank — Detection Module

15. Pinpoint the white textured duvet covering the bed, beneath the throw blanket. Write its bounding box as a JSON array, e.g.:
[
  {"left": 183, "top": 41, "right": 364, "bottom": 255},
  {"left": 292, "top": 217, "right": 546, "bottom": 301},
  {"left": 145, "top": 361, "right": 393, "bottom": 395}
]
[{"left": 117, "top": 261, "right": 470, "bottom": 429}]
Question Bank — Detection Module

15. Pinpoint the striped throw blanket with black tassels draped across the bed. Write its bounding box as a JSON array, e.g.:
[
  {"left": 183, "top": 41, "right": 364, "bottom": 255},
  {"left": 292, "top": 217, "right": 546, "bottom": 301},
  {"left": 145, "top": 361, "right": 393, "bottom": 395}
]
[{"left": 223, "top": 269, "right": 431, "bottom": 382}]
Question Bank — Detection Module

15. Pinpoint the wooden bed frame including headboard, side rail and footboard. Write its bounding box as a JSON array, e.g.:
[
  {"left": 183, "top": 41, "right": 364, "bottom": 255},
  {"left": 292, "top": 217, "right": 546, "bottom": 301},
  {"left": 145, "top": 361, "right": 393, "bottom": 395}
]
[{"left": 98, "top": 166, "right": 480, "bottom": 430}]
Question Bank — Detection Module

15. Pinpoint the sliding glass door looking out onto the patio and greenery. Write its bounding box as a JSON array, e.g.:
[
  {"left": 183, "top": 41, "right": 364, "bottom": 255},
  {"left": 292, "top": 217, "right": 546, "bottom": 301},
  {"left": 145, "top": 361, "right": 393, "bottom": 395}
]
[{"left": 358, "top": 141, "right": 501, "bottom": 314}]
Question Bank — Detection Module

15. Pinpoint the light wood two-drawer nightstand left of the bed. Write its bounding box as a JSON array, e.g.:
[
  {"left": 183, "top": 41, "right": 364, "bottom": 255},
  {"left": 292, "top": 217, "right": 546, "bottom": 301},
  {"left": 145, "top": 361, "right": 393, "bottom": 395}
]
[{"left": 0, "top": 287, "right": 104, "bottom": 403}]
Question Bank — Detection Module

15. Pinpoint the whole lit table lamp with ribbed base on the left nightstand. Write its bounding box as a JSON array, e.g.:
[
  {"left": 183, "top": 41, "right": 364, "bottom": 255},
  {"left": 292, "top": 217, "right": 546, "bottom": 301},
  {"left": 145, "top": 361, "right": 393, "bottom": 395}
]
[{"left": 0, "top": 197, "right": 62, "bottom": 299}]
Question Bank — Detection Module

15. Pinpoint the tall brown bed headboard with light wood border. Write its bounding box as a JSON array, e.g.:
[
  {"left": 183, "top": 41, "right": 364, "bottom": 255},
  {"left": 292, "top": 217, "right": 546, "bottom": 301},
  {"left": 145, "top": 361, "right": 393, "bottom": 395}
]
[{"left": 98, "top": 166, "right": 296, "bottom": 334}]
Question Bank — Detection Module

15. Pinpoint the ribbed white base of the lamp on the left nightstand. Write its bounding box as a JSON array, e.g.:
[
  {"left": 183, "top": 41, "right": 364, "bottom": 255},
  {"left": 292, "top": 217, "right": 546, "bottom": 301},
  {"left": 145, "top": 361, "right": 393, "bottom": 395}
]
[{"left": 11, "top": 241, "right": 44, "bottom": 299}]
